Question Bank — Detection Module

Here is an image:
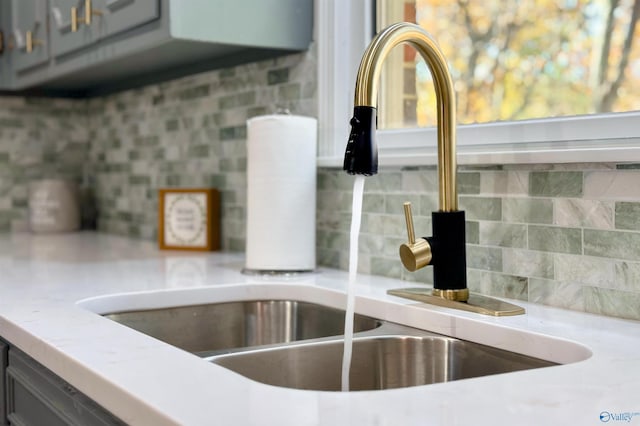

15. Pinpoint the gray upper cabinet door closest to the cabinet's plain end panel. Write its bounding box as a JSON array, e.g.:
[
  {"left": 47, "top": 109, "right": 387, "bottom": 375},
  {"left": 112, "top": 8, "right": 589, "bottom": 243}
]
[{"left": 51, "top": 0, "right": 160, "bottom": 57}]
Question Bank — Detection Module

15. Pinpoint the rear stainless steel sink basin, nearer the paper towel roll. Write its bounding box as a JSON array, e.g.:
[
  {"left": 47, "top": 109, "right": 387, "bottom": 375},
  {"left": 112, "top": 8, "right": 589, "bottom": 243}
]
[{"left": 104, "top": 300, "right": 380, "bottom": 356}]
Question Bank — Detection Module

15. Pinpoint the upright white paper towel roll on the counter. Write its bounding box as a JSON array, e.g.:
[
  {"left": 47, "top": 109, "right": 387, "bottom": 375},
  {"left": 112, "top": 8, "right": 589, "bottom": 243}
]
[{"left": 246, "top": 115, "right": 317, "bottom": 272}]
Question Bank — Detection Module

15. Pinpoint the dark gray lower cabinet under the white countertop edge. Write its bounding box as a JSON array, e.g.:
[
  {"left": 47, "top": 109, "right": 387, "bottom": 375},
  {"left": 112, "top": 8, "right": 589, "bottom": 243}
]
[{"left": 0, "top": 341, "right": 125, "bottom": 426}]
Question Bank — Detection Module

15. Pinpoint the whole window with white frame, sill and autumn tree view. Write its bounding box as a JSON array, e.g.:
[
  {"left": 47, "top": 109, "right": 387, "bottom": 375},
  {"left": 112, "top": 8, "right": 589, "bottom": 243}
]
[{"left": 316, "top": 0, "right": 640, "bottom": 166}]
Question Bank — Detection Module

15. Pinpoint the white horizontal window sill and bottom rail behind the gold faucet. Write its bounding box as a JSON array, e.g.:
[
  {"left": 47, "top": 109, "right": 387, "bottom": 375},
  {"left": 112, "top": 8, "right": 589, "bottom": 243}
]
[{"left": 318, "top": 112, "right": 640, "bottom": 167}]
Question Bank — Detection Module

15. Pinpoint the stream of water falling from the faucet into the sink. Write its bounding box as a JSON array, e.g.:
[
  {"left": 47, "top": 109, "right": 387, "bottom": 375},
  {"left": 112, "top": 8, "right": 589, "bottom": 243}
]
[{"left": 342, "top": 175, "right": 365, "bottom": 392}]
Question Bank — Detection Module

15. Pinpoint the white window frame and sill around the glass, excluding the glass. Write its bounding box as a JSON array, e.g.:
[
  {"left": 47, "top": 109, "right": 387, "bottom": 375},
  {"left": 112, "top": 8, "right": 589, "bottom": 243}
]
[{"left": 315, "top": 0, "right": 640, "bottom": 167}]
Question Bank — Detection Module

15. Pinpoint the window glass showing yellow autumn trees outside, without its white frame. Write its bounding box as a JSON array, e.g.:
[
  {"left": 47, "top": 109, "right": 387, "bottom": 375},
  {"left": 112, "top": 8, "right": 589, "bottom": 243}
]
[{"left": 377, "top": 0, "right": 640, "bottom": 128}]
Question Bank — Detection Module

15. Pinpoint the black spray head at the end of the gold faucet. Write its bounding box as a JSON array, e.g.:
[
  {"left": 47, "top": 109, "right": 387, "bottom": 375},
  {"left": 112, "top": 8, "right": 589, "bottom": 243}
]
[{"left": 342, "top": 106, "right": 378, "bottom": 176}]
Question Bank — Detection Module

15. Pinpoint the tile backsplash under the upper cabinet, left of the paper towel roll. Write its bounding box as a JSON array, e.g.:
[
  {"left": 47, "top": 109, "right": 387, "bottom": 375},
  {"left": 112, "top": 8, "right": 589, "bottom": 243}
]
[{"left": 88, "top": 51, "right": 317, "bottom": 251}]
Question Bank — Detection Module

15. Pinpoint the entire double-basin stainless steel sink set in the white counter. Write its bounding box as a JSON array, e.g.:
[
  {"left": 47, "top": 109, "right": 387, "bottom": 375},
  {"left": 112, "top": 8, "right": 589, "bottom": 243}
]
[{"left": 104, "top": 300, "right": 557, "bottom": 391}]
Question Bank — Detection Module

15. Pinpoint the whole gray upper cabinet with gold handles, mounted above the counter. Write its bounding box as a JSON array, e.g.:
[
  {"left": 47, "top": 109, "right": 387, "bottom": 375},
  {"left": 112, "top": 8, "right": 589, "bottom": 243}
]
[{"left": 7, "top": 0, "right": 313, "bottom": 96}]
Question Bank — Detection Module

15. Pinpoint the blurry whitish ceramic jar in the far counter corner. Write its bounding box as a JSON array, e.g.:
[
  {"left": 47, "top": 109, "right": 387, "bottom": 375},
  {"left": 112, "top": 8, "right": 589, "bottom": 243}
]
[{"left": 29, "top": 179, "right": 80, "bottom": 233}]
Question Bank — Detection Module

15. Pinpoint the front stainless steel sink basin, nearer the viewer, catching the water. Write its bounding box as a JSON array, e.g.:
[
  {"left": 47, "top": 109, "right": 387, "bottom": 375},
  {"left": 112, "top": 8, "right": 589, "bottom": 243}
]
[{"left": 211, "top": 323, "right": 556, "bottom": 391}]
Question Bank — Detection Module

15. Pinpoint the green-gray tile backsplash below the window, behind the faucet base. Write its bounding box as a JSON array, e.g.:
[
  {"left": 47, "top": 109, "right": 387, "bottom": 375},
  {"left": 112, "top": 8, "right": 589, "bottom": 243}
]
[{"left": 317, "top": 164, "right": 640, "bottom": 319}]
